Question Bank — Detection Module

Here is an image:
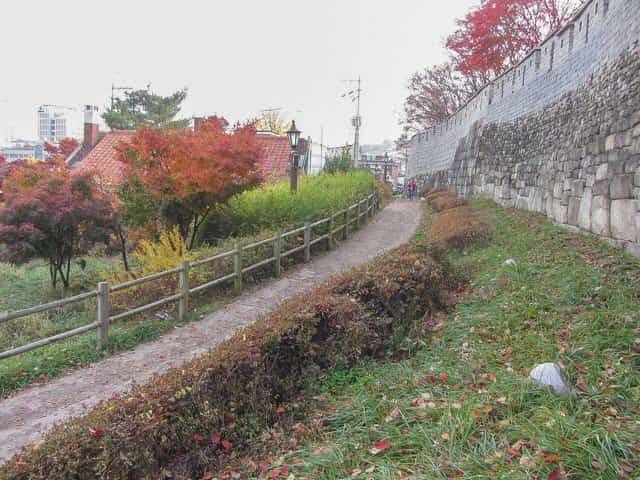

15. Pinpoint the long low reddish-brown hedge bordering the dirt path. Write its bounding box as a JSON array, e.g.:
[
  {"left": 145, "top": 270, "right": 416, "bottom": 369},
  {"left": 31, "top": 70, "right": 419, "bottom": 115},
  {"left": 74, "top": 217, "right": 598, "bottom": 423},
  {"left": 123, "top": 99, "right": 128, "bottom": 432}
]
[{"left": 0, "top": 234, "right": 459, "bottom": 480}]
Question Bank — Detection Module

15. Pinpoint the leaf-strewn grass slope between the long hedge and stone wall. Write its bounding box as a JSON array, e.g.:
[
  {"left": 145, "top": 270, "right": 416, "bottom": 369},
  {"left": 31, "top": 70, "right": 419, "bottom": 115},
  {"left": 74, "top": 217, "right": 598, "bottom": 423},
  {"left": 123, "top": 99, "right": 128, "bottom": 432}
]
[{"left": 236, "top": 201, "right": 640, "bottom": 480}]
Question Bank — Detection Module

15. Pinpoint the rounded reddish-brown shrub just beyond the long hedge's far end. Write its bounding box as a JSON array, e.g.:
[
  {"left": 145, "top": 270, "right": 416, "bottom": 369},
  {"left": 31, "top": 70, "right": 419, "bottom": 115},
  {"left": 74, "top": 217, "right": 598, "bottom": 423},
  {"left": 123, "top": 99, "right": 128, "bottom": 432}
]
[{"left": 427, "top": 206, "right": 491, "bottom": 249}]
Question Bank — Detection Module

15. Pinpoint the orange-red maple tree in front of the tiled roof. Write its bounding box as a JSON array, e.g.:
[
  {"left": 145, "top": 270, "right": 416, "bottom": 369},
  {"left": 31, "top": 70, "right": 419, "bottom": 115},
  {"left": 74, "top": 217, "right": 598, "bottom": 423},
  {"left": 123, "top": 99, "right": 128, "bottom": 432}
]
[{"left": 119, "top": 117, "right": 261, "bottom": 248}]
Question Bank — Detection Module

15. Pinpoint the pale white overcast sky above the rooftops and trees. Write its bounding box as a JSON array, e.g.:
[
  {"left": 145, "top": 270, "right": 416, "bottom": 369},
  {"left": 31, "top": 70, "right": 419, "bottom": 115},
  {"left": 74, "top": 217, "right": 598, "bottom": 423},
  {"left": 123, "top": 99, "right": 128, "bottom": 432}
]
[{"left": 0, "top": 0, "right": 478, "bottom": 149}]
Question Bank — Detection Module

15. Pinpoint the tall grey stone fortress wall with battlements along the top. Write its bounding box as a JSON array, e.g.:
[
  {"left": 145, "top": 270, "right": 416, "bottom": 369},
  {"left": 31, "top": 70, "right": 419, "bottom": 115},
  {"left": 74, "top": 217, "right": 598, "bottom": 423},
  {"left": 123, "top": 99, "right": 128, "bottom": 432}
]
[{"left": 407, "top": 0, "right": 640, "bottom": 253}]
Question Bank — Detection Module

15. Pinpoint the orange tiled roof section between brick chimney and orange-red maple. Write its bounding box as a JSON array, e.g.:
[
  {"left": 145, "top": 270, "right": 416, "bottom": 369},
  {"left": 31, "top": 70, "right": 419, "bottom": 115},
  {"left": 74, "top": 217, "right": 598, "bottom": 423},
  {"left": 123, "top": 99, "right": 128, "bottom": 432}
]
[{"left": 74, "top": 130, "right": 136, "bottom": 186}]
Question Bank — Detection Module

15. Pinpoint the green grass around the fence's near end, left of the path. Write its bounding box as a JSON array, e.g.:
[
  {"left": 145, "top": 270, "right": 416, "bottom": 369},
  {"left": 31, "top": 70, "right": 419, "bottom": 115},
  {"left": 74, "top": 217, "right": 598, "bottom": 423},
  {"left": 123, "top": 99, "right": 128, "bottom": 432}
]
[{"left": 0, "top": 257, "right": 233, "bottom": 398}]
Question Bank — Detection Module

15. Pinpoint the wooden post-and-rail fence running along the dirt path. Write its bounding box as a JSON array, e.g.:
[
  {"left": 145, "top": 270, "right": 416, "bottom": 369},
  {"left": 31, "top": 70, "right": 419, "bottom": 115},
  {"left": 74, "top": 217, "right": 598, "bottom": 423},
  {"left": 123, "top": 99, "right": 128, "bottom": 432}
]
[{"left": 0, "top": 191, "right": 379, "bottom": 359}]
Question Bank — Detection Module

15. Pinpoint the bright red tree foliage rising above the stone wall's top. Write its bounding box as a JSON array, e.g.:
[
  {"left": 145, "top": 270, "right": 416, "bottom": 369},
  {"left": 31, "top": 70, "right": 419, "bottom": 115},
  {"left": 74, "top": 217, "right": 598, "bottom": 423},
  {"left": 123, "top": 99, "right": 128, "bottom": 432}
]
[{"left": 446, "top": 0, "right": 580, "bottom": 83}]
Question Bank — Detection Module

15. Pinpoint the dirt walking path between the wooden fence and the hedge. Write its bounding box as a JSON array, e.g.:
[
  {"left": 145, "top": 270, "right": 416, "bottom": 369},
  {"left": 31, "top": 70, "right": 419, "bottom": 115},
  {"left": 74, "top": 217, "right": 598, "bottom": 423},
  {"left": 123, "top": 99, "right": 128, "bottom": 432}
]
[{"left": 0, "top": 200, "right": 421, "bottom": 463}]
